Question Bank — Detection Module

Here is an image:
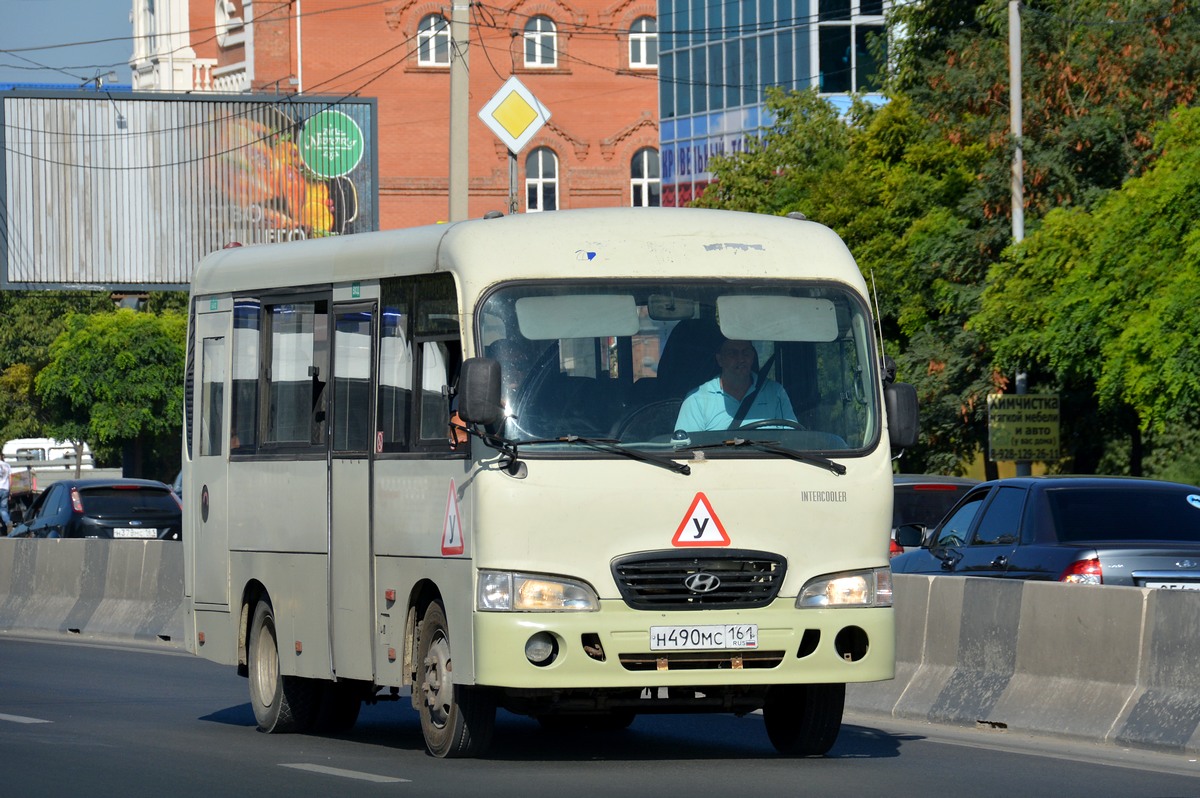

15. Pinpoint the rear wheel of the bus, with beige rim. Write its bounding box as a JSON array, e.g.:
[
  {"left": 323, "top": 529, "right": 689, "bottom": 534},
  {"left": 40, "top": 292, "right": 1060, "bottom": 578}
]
[{"left": 248, "top": 601, "right": 319, "bottom": 733}]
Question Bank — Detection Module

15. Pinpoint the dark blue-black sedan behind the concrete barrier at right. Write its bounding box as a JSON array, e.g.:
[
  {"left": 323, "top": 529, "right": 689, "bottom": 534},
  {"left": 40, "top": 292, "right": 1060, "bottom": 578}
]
[{"left": 892, "top": 476, "right": 1200, "bottom": 590}]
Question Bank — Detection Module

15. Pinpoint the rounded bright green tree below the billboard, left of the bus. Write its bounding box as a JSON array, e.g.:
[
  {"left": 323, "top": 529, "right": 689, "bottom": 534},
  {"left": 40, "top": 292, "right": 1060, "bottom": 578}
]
[{"left": 36, "top": 310, "right": 187, "bottom": 479}]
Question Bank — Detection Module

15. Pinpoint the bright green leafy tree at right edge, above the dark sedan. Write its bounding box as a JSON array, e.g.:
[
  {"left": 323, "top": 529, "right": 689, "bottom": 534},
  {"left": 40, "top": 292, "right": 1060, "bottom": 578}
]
[{"left": 973, "top": 109, "right": 1200, "bottom": 478}]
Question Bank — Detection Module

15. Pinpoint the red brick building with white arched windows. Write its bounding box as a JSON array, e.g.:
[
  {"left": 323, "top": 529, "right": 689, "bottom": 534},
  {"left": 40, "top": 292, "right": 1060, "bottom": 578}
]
[{"left": 150, "top": 0, "right": 660, "bottom": 229}]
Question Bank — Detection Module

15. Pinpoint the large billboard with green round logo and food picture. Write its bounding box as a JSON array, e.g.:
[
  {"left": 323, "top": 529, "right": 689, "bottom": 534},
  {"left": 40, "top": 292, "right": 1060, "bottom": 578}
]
[{"left": 0, "top": 91, "right": 379, "bottom": 292}]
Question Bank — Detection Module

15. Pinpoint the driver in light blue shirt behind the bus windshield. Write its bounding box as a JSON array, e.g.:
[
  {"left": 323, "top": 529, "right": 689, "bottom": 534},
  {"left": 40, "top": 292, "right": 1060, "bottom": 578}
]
[{"left": 674, "top": 338, "right": 796, "bottom": 432}]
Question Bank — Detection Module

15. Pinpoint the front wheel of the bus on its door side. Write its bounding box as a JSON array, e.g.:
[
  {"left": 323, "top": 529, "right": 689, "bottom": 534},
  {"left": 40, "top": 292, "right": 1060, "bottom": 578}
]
[{"left": 414, "top": 601, "right": 496, "bottom": 758}]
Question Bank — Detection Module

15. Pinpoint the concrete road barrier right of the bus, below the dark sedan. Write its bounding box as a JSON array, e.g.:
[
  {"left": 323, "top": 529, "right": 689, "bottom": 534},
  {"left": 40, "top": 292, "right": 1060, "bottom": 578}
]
[{"left": 846, "top": 575, "right": 1200, "bottom": 752}]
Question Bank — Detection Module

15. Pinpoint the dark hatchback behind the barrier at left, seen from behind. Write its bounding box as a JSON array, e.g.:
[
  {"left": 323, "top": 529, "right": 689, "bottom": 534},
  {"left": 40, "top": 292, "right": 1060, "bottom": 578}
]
[{"left": 8, "top": 479, "right": 182, "bottom": 540}]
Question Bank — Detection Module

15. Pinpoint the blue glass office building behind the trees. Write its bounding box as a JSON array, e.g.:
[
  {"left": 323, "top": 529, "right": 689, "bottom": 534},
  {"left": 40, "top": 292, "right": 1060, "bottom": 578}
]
[{"left": 659, "top": 0, "right": 889, "bottom": 206}]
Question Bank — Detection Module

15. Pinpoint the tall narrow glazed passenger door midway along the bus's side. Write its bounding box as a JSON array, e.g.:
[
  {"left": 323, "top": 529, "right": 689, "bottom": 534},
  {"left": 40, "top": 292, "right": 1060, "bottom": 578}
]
[{"left": 329, "top": 302, "right": 376, "bottom": 680}]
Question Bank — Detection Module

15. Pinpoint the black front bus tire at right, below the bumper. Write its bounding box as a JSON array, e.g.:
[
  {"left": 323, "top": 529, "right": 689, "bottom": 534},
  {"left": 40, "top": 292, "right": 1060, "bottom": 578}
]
[{"left": 762, "top": 684, "right": 846, "bottom": 756}]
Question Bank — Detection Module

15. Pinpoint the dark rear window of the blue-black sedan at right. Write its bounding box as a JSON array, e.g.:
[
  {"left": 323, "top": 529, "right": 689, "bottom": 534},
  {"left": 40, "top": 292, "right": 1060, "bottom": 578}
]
[{"left": 1046, "top": 487, "right": 1200, "bottom": 542}]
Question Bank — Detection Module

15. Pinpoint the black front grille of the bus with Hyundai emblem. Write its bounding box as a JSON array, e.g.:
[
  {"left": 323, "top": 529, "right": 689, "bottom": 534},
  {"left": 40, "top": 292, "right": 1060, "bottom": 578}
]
[{"left": 612, "top": 550, "right": 787, "bottom": 610}]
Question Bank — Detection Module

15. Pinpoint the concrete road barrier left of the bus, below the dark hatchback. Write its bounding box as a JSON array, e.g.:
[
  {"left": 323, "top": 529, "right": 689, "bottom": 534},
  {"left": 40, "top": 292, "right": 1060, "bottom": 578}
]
[{"left": 0, "top": 539, "right": 185, "bottom": 641}]
